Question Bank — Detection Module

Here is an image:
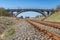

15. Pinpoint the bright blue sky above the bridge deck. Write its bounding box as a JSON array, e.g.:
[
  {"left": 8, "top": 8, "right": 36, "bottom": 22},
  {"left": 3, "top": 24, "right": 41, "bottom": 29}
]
[{"left": 0, "top": 0, "right": 60, "bottom": 16}]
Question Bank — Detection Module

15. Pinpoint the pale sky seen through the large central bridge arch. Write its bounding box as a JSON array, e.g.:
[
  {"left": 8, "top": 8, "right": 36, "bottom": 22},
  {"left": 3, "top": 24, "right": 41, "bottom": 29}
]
[{"left": 17, "top": 11, "right": 42, "bottom": 18}]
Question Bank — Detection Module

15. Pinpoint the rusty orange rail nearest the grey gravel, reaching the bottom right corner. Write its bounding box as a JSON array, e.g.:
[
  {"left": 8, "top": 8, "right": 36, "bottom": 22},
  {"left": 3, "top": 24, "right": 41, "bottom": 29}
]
[{"left": 27, "top": 19, "right": 60, "bottom": 40}]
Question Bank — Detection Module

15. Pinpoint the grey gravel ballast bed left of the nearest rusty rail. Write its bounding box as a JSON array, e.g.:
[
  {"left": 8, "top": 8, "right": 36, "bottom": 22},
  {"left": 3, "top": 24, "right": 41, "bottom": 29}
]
[{"left": 4, "top": 20, "right": 53, "bottom": 40}]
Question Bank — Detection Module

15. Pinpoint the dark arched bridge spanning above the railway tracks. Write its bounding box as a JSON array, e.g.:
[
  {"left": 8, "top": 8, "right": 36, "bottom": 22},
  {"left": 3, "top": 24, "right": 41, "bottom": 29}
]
[{"left": 6, "top": 9, "right": 52, "bottom": 17}]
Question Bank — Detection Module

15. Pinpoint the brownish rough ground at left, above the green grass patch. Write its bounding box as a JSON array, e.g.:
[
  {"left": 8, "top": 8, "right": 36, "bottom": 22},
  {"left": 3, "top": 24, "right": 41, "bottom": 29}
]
[{"left": 0, "top": 17, "right": 18, "bottom": 34}]
